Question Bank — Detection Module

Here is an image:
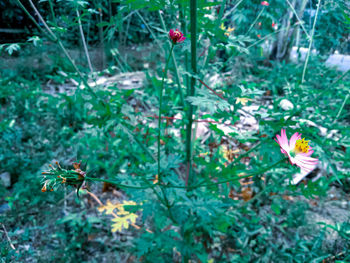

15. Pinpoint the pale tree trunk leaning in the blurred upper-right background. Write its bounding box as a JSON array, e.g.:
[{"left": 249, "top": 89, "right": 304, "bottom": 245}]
[{"left": 270, "top": 0, "right": 308, "bottom": 61}]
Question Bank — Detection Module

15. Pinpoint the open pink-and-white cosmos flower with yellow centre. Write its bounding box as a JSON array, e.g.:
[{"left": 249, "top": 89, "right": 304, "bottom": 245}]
[{"left": 275, "top": 129, "right": 318, "bottom": 172}]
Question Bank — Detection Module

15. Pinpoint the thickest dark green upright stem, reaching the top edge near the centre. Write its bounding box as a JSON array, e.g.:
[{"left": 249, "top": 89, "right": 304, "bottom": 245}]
[{"left": 186, "top": 0, "right": 197, "bottom": 190}]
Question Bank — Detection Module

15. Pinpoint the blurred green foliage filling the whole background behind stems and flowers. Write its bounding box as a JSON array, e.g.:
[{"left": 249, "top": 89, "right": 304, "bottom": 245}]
[{"left": 0, "top": 0, "right": 350, "bottom": 262}]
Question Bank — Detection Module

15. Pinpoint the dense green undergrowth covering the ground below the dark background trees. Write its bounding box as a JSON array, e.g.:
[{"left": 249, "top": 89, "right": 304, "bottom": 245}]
[{"left": 0, "top": 1, "right": 350, "bottom": 262}]
